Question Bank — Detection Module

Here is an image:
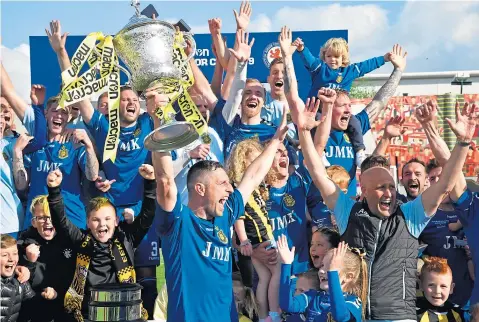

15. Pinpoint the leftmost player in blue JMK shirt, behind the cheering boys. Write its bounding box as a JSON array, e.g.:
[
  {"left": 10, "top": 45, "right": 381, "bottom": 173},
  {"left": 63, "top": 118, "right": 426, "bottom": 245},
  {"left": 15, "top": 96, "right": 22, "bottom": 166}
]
[{"left": 14, "top": 97, "right": 98, "bottom": 229}]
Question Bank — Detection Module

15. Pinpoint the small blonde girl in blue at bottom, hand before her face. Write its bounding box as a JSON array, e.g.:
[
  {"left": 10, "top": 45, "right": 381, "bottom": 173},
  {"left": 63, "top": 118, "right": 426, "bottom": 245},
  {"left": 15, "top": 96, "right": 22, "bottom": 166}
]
[{"left": 278, "top": 235, "right": 368, "bottom": 322}]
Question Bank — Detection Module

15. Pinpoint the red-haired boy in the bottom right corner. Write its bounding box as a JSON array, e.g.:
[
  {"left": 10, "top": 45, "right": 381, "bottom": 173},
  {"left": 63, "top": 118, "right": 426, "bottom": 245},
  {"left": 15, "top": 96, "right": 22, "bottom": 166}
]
[{"left": 416, "top": 256, "right": 464, "bottom": 322}]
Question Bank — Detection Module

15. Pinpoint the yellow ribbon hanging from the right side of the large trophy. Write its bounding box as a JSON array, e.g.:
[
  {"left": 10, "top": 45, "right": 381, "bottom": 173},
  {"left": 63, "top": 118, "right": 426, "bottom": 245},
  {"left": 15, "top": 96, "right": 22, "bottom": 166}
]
[{"left": 156, "top": 31, "right": 211, "bottom": 144}]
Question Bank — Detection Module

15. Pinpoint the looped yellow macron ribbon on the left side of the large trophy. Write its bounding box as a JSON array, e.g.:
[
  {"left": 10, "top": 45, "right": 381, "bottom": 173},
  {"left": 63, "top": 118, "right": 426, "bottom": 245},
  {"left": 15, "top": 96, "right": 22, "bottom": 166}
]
[{"left": 59, "top": 32, "right": 120, "bottom": 162}]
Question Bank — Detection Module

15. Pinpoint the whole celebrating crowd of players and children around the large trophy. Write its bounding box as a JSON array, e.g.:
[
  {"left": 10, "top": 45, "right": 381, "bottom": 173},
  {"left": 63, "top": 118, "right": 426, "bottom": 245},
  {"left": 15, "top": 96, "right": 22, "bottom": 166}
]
[{"left": 0, "top": 2, "right": 479, "bottom": 322}]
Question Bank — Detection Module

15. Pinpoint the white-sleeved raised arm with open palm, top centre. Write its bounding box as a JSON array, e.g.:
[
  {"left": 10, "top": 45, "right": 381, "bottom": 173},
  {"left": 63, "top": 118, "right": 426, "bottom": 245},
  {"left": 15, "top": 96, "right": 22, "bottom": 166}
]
[{"left": 222, "top": 29, "right": 254, "bottom": 124}]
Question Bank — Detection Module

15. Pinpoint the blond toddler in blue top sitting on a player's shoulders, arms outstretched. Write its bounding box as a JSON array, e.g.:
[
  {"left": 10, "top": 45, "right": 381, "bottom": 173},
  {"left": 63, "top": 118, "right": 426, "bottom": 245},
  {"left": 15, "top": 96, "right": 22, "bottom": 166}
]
[{"left": 293, "top": 38, "right": 390, "bottom": 166}]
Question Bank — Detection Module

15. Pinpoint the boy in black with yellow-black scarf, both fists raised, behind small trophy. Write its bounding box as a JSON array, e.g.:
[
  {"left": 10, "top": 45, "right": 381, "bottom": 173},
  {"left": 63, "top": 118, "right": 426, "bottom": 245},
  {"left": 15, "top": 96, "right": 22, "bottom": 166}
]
[{"left": 47, "top": 164, "right": 156, "bottom": 321}]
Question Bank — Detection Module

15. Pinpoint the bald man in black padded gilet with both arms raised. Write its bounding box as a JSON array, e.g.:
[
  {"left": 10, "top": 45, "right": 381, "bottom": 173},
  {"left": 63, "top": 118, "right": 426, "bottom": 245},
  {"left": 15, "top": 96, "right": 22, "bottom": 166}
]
[{"left": 288, "top": 85, "right": 477, "bottom": 321}]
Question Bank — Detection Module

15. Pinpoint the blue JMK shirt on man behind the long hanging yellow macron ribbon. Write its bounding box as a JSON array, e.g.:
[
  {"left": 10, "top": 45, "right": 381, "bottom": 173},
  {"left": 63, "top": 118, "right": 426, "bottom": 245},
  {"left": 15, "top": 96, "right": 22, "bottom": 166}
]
[{"left": 86, "top": 110, "right": 154, "bottom": 206}]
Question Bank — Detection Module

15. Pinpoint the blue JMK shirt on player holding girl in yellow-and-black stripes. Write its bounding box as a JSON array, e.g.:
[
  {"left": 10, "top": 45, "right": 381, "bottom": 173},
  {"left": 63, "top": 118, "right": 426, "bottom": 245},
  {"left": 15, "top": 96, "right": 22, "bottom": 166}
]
[{"left": 266, "top": 166, "right": 315, "bottom": 274}]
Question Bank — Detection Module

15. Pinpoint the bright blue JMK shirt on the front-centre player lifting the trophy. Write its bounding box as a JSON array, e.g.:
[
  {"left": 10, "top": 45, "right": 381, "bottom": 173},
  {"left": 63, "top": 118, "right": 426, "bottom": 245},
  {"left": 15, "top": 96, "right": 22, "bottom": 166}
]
[{"left": 156, "top": 190, "right": 244, "bottom": 322}]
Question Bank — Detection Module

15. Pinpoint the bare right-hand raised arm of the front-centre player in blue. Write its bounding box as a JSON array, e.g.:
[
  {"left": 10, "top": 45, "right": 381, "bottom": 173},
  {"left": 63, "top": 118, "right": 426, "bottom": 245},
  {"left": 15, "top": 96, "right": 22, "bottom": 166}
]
[{"left": 238, "top": 109, "right": 288, "bottom": 204}]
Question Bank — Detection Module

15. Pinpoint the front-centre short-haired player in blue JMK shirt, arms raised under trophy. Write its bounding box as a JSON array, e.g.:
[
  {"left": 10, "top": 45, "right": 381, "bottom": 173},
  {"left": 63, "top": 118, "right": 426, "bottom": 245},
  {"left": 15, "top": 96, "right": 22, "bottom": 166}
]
[{"left": 152, "top": 88, "right": 287, "bottom": 322}]
